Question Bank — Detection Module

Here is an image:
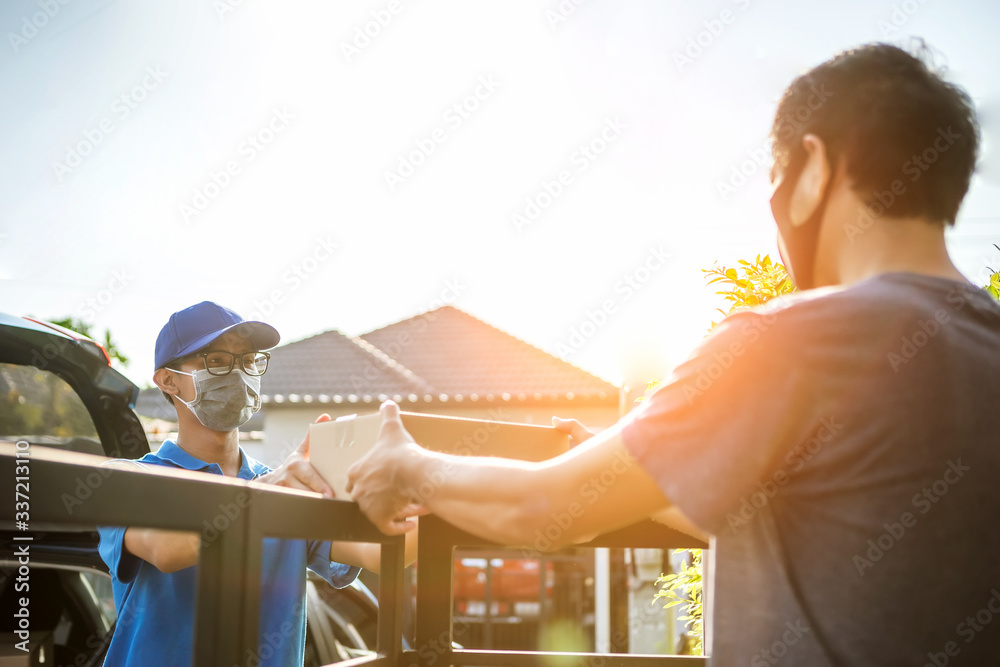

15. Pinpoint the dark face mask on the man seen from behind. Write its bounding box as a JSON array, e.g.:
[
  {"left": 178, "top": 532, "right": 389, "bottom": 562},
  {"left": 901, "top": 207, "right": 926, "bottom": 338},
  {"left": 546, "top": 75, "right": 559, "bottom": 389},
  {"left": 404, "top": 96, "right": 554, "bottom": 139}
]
[{"left": 771, "top": 161, "right": 829, "bottom": 290}]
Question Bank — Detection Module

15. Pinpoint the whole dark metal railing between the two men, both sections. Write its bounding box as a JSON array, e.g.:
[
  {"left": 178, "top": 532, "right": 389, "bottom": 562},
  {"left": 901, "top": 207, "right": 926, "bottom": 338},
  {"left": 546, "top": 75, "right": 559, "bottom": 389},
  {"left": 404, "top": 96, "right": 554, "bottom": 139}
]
[{"left": 0, "top": 445, "right": 706, "bottom": 667}]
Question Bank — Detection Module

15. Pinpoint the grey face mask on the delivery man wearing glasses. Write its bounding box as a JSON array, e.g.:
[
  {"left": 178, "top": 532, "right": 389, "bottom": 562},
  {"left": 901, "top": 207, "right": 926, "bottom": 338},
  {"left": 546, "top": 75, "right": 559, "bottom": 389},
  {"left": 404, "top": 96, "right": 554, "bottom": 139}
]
[{"left": 167, "top": 367, "right": 260, "bottom": 431}]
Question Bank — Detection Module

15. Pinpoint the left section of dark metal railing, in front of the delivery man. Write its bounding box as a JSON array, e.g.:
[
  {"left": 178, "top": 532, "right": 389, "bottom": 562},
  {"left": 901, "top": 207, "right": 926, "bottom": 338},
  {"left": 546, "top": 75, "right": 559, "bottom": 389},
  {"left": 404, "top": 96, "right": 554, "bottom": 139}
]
[{"left": 0, "top": 445, "right": 404, "bottom": 667}]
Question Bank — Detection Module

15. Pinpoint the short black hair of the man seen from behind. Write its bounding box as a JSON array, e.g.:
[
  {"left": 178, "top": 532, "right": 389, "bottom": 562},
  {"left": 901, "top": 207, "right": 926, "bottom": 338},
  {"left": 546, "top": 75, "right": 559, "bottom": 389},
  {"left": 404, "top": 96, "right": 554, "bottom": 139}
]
[{"left": 771, "top": 41, "right": 979, "bottom": 224}]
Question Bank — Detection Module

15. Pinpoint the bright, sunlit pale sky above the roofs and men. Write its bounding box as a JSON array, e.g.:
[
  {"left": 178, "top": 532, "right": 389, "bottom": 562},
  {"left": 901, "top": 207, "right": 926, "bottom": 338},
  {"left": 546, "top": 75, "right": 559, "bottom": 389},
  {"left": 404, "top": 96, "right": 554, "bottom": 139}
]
[{"left": 0, "top": 0, "right": 1000, "bottom": 392}]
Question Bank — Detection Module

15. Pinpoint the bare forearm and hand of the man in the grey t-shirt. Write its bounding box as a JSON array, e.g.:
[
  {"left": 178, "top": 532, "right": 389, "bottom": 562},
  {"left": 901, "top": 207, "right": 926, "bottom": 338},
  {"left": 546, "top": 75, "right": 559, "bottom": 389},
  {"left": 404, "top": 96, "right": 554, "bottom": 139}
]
[{"left": 348, "top": 401, "right": 670, "bottom": 548}]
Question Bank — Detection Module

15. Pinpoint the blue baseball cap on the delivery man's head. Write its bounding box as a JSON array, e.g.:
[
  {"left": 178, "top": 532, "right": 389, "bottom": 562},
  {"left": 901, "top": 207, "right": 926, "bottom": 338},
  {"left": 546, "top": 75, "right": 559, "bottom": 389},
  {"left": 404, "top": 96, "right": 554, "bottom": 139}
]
[{"left": 155, "top": 301, "right": 281, "bottom": 368}]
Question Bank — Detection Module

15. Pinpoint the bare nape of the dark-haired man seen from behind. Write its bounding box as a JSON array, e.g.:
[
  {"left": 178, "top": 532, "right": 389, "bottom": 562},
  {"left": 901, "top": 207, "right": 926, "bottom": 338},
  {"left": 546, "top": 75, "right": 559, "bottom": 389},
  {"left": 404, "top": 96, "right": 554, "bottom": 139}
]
[{"left": 836, "top": 218, "right": 968, "bottom": 285}]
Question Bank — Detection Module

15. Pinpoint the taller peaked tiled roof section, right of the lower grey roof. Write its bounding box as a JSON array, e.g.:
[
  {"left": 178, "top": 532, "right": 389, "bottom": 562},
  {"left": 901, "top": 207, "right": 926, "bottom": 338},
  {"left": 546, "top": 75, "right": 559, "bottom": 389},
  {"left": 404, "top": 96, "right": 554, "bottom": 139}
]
[{"left": 361, "top": 306, "right": 618, "bottom": 402}]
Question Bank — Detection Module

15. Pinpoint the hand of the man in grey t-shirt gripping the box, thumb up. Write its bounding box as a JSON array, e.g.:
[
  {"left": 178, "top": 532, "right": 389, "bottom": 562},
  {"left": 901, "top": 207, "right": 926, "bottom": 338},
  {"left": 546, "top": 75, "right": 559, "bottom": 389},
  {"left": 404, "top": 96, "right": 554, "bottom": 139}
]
[{"left": 347, "top": 401, "right": 426, "bottom": 535}]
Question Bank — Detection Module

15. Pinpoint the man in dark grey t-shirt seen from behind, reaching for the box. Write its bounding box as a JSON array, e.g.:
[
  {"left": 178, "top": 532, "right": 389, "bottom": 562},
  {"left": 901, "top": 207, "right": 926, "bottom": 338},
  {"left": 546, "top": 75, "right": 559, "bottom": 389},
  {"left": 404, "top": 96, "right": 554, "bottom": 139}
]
[{"left": 349, "top": 44, "right": 1000, "bottom": 667}]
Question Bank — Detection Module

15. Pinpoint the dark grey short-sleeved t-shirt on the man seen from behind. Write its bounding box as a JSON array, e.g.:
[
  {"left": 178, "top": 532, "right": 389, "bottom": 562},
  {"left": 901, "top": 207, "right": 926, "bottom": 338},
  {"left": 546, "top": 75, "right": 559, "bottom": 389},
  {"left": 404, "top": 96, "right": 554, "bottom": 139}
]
[{"left": 624, "top": 273, "right": 1000, "bottom": 667}]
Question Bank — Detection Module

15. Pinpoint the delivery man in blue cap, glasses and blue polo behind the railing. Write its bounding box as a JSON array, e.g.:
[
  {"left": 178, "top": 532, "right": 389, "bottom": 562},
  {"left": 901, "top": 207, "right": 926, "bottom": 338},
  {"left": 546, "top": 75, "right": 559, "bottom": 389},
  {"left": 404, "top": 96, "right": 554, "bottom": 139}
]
[{"left": 99, "top": 301, "right": 416, "bottom": 667}]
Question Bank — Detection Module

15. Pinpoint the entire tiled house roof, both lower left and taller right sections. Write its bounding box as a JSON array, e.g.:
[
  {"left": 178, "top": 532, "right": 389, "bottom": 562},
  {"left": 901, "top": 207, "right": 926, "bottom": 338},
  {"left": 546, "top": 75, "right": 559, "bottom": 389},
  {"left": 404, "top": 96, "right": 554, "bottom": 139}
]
[{"left": 261, "top": 306, "right": 619, "bottom": 406}]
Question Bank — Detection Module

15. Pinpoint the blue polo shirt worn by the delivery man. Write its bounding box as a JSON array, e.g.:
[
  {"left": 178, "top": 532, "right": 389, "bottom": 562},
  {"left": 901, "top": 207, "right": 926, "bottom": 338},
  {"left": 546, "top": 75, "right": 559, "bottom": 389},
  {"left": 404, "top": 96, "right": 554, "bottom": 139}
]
[{"left": 98, "top": 440, "right": 361, "bottom": 667}]
